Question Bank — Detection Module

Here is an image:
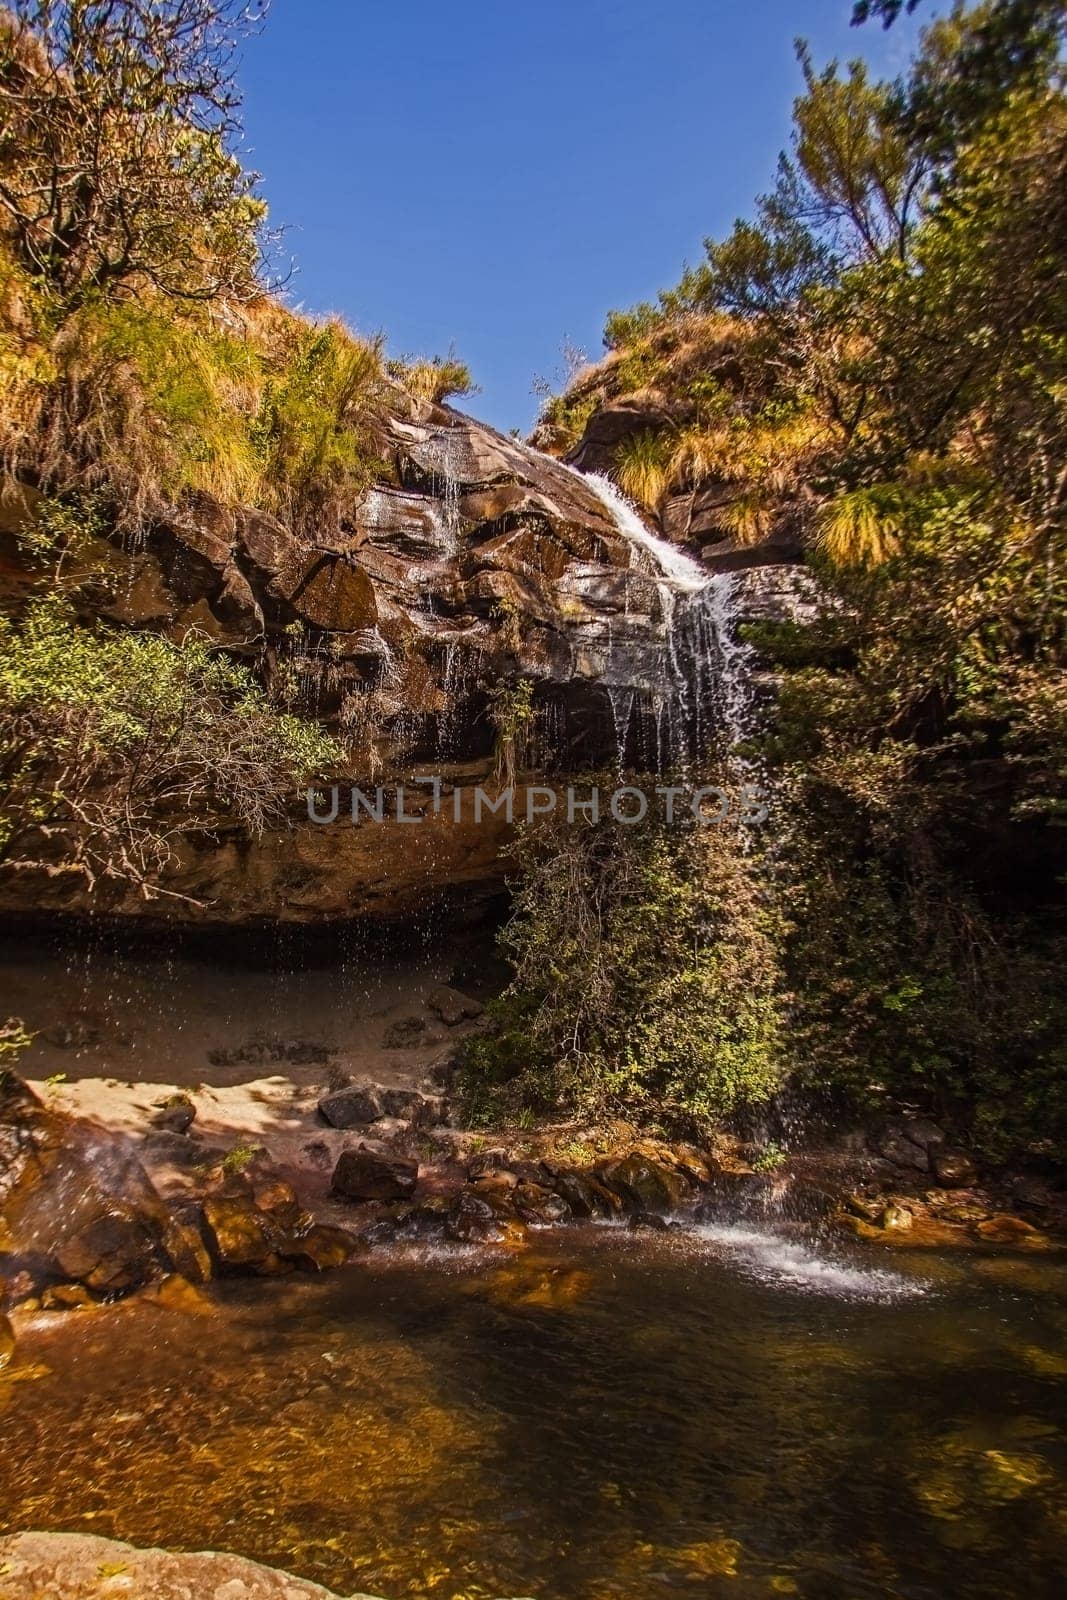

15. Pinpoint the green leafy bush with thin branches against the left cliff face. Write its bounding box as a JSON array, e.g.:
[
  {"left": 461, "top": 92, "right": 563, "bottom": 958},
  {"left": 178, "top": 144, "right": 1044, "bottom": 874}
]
[{"left": 0, "top": 598, "right": 339, "bottom": 899}]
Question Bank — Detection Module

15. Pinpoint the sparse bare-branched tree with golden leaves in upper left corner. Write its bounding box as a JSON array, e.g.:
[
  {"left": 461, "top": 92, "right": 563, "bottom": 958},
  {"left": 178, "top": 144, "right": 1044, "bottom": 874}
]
[{"left": 0, "top": 0, "right": 266, "bottom": 315}]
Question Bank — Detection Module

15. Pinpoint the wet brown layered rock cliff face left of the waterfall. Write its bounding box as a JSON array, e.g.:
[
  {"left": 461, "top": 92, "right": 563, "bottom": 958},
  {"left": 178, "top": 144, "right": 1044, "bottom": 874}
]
[{"left": 0, "top": 397, "right": 812, "bottom": 925}]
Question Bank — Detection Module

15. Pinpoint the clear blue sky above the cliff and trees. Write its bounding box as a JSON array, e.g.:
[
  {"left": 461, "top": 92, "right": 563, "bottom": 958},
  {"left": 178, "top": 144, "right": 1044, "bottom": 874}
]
[{"left": 242, "top": 0, "right": 931, "bottom": 430}]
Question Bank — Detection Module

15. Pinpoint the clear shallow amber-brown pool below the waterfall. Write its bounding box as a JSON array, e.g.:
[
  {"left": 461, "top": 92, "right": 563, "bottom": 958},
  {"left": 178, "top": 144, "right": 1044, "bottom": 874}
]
[{"left": 0, "top": 1227, "right": 1067, "bottom": 1600}]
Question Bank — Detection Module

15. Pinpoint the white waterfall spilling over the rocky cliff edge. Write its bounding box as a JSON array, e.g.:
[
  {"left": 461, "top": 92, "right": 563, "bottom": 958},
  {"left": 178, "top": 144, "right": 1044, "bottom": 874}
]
[{"left": 568, "top": 467, "right": 755, "bottom": 768}]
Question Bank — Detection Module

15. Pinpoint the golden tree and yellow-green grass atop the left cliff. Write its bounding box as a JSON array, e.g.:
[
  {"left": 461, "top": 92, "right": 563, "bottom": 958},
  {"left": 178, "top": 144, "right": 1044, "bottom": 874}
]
[{"left": 0, "top": 0, "right": 470, "bottom": 538}]
